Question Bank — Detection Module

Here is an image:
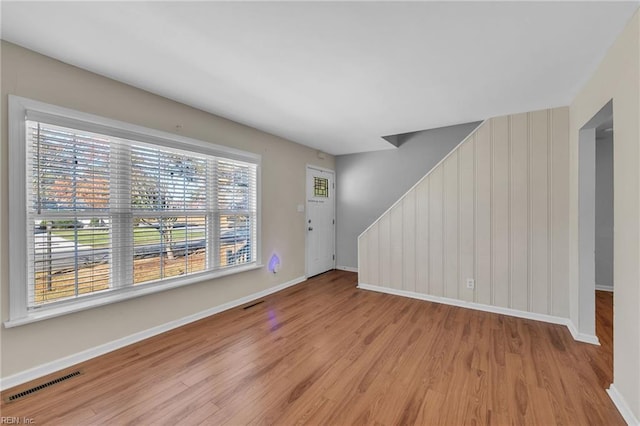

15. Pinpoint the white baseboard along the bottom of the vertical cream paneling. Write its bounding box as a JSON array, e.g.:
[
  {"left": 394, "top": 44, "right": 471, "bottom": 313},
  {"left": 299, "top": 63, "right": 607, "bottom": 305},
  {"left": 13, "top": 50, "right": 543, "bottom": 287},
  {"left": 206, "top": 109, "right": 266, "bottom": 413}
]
[{"left": 358, "top": 283, "right": 600, "bottom": 345}]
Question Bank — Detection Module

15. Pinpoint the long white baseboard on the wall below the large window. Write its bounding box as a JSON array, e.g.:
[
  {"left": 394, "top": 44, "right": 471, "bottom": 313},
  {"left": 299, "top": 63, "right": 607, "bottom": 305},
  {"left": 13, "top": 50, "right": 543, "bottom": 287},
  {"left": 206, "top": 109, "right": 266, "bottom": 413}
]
[{"left": 0, "top": 276, "right": 307, "bottom": 390}]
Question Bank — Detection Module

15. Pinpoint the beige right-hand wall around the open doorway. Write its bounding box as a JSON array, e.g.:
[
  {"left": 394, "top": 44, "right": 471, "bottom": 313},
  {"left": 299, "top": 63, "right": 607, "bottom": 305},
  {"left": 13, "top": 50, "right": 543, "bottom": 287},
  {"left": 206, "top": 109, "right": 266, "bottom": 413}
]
[{"left": 570, "top": 12, "right": 640, "bottom": 419}]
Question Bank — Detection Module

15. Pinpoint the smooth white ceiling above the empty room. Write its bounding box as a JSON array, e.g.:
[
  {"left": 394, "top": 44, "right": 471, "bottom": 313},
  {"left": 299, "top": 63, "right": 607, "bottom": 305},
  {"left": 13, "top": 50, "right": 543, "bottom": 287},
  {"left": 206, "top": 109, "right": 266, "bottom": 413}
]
[{"left": 1, "top": 1, "right": 638, "bottom": 155}]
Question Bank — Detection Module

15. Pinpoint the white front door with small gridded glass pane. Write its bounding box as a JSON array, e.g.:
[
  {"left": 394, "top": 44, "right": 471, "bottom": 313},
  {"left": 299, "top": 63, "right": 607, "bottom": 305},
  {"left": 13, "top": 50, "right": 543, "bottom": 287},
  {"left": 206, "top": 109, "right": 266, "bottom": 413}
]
[{"left": 306, "top": 166, "right": 335, "bottom": 277}]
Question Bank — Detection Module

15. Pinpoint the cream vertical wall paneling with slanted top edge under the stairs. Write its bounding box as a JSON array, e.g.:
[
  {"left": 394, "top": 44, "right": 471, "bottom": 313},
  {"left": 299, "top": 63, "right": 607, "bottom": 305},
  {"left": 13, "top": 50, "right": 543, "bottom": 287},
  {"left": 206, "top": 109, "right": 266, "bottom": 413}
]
[{"left": 358, "top": 108, "right": 569, "bottom": 317}]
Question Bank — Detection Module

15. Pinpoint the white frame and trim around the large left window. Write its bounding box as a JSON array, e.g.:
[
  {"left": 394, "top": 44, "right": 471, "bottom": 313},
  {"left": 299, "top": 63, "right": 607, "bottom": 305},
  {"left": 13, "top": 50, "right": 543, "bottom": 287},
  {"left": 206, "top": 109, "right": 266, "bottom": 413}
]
[{"left": 4, "top": 95, "right": 263, "bottom": 328}]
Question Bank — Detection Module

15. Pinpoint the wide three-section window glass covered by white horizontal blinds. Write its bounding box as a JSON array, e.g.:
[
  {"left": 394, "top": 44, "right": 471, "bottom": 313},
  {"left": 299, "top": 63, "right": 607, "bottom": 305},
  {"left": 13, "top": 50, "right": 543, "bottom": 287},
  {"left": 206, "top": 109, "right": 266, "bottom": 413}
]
[{"left": 12, "top": 95, "right": 258, "bottom": 322}]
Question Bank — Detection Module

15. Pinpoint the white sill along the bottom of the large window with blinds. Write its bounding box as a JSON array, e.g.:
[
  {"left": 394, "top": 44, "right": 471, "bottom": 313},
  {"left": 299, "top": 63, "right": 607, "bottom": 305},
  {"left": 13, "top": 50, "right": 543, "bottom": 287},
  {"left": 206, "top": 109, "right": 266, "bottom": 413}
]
[{"left": 4, "top": 263, "right": 264, "bottom": 328}]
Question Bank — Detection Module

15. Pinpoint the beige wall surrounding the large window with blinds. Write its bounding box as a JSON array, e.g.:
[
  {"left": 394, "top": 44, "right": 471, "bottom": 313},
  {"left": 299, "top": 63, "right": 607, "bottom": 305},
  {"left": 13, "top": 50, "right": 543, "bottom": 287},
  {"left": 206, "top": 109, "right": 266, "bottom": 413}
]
[{"left": 0, "top": 42, "right": 334, "bottom": 378}]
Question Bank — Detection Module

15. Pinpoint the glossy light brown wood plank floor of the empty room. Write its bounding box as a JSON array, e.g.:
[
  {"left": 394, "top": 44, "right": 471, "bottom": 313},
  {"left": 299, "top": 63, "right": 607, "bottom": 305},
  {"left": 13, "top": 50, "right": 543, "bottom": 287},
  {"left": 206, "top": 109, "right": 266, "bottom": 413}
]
[{"left": 0, "top": 271, "right": 624, "bottom": 425}]
